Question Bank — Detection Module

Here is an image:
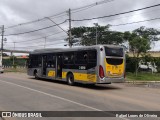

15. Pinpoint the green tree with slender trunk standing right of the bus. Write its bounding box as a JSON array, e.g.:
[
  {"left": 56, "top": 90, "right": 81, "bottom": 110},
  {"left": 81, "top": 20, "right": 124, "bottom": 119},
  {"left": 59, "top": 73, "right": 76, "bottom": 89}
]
[{"left": 124, "top": 27, "right": 160, "bottom": 76}]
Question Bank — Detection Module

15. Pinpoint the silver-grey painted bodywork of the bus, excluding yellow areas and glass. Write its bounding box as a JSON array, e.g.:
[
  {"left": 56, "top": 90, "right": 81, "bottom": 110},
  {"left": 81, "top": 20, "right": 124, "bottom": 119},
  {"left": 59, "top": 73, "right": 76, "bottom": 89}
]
[{"left": 28, "top": 45, "right": 125, "bottom": 83}]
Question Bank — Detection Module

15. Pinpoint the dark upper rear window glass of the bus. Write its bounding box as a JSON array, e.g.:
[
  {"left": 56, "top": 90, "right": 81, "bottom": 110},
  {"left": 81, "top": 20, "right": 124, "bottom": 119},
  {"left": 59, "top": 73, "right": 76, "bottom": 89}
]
[{"left": 104, "top": 47, "right": 123, "bottom": 57}]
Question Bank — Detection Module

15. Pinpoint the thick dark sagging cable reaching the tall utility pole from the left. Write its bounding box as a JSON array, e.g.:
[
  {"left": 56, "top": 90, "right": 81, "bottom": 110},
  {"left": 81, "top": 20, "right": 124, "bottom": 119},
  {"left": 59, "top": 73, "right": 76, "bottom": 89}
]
[{"left": 4, "top": 20, "right": 67, "bottom": 36}]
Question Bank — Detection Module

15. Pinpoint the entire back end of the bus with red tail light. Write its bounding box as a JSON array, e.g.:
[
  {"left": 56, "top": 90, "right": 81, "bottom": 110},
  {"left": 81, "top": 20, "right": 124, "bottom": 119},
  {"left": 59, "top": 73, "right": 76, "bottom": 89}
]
[{"left": 98, "top": 45, "right": 125, "bottom": 83}]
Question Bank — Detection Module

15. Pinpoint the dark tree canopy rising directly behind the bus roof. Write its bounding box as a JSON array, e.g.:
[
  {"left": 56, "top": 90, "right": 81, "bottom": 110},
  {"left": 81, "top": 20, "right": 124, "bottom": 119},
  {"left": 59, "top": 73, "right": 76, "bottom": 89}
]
[{"left": 66, "top": 25, "right": 124, "bottom": 46}]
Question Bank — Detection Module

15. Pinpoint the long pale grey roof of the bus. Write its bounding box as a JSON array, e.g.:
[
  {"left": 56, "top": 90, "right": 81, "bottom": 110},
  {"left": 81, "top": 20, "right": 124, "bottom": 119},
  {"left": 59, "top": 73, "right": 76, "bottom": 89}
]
[{"left": 30, "top": 44, "right": 123, "bottom": 54}]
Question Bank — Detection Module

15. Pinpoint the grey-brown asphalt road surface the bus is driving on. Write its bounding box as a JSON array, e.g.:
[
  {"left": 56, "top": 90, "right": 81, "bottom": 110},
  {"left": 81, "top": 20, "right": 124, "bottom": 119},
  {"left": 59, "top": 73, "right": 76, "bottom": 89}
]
[{"left": 0, "top": 73, "right": 160, "bottom": 120}]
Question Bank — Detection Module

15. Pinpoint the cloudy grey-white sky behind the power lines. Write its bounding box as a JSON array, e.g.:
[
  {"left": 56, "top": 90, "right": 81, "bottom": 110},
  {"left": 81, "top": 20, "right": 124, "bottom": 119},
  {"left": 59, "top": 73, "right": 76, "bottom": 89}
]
[{"left": 0, "top": 0, "right": 160, "bottom": 55}]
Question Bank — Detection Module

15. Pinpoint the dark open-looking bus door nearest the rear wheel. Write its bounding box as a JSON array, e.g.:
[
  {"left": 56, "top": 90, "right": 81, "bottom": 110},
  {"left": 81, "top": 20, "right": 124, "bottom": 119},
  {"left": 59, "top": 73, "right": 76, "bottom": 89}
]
[{"left": 56, "top": 54, "right": 62, "bottom": 78}]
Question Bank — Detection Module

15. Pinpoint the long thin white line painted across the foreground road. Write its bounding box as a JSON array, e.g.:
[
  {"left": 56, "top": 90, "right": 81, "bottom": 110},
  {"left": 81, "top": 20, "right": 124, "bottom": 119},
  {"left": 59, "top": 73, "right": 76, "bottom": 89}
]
[{"left": 0, "top": 80, "right": 103, "bottom": 111}]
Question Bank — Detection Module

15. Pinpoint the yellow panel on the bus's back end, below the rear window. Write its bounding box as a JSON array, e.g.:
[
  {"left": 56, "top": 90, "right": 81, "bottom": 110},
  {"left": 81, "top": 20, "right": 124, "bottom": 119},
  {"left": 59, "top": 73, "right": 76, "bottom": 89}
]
[{"left": 104, "top": 59, "right": 124, "bottom": 77}]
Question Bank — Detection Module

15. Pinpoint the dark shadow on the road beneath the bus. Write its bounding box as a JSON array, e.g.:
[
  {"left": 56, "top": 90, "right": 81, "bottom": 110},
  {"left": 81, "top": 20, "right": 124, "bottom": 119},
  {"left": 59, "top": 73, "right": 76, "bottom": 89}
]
[{"left": 29, "top": 78, "right": 122, "bottom": 90}]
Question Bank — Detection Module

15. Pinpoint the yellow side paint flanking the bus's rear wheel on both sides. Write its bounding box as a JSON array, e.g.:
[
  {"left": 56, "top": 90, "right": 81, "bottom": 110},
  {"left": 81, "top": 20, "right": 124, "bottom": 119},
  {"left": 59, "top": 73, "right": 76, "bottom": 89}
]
[{"left": 62, "top": 72, "right": 96, "bottom": 82}]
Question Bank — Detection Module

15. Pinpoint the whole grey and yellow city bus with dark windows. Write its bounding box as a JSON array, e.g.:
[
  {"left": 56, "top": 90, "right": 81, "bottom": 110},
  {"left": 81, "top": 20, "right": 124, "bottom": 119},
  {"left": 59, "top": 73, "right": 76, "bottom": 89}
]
[{"left": 28, "top": 45, "right": 125, "bottom": 85}]
